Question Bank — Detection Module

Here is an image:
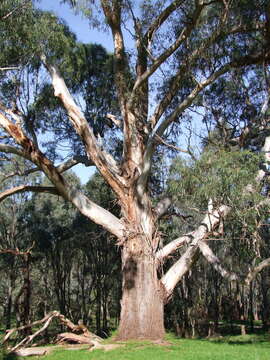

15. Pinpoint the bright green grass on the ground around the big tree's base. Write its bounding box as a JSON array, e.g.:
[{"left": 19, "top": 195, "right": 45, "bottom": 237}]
[{"left": 1, "top": 334, "right": 270, "bottom": 360}]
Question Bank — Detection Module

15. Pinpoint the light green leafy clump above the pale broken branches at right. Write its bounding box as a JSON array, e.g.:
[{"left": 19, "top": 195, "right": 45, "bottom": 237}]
[{"left": 169, "top": 149, "right": 262, "bottom": 209}]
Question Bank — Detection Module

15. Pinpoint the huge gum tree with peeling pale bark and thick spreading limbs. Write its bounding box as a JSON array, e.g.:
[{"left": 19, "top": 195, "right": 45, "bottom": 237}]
[{"left": 0, "top": 0, "right": 270, "bottom": 339}]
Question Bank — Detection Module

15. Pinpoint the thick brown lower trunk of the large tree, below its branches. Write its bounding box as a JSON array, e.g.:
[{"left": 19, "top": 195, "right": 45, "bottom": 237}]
[{"left": 118, "top": 239, "right": 165, "bottom": 340}]
